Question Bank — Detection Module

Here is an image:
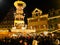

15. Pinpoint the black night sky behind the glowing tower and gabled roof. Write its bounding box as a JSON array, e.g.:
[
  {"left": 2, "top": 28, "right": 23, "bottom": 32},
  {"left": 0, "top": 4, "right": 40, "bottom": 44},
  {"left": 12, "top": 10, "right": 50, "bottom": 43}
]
[{"left": 0, "top": 0, "right": 60, "bottom": 19}]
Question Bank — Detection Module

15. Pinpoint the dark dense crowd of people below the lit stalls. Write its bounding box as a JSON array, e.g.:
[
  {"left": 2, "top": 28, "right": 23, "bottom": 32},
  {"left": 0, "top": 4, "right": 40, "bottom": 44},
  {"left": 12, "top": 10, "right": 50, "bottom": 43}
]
[{"left": 0, "top": 33, "right": 59, "bottom": 45}]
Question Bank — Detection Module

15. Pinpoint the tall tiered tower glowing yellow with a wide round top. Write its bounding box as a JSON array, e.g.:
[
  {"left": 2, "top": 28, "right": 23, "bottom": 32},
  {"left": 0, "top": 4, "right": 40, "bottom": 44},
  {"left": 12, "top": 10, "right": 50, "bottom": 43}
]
[{"left": 14, "top": 0, "right": 26, "bottom": 28}]
